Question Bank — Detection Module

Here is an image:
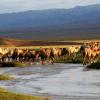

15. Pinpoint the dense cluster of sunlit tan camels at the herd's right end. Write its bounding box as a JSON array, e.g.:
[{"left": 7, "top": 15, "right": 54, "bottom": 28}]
[{"left": 81, "top": 42, "right": 100, "bottom": 64}]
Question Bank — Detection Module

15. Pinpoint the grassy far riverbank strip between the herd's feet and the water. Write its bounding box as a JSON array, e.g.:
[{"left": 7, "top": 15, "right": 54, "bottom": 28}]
[{"left": 0, "top": 54, "right": 83, "bottom": 67}]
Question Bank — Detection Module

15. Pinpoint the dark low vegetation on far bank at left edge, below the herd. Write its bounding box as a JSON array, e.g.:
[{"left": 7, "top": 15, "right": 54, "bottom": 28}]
[{"left": 0, "top": 62, "right": 26, "bottom": 67}]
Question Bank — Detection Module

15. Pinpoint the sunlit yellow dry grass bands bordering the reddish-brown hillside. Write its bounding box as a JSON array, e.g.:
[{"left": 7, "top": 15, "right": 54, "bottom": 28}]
[{"left": 0, "top": 39, "right": 100, "bottom": 49}]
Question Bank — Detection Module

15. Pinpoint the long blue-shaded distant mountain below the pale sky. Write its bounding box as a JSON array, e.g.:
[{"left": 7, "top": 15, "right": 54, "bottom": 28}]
[{"left": 0, "top": 4, "right": 100, "bottom": 39}]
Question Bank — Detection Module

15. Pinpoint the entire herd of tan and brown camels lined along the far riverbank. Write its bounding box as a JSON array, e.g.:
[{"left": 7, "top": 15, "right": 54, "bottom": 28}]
[{"left": 0, "top": 42, "right": 100, "bottom": 64}]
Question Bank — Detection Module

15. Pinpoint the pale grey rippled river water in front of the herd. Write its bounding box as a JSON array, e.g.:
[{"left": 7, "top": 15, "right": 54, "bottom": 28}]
[{"left": 0, "top": 64, "right": 100, "bottom": 100}]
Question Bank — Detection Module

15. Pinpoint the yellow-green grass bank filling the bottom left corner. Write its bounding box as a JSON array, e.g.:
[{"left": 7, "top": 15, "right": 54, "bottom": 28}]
[{"left": 0, "top": 88, "right": 50, "bottom": 100}]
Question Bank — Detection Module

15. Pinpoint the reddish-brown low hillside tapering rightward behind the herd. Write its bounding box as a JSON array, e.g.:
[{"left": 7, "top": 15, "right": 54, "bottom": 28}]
[{"left": 0, "top": 38, "right": 82, "bottom": 47}]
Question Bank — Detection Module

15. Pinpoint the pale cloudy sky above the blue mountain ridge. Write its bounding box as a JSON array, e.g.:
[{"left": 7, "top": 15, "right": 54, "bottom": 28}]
[{"left": 0, "top": 0, "right": 100, "bottom": 13}]
